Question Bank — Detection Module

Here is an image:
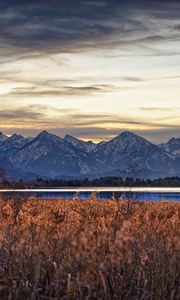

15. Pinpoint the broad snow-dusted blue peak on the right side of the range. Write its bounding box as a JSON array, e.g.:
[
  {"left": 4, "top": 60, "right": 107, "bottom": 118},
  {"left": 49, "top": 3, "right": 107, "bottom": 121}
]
[{"left": 91, "top": 131, "right": 173, "bottom": 174}]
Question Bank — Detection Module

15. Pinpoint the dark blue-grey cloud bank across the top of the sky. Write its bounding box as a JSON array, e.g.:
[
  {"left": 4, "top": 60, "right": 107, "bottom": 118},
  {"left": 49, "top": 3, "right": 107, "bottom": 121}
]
[{"left": 0, "top": 0, "right": 180, "bottom": 61}]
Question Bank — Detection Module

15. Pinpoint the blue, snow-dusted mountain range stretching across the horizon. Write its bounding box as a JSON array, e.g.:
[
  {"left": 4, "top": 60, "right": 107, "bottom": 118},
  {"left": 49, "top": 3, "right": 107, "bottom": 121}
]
[{"left": 0, "top": 131, "right": 180, "bottom": 179}]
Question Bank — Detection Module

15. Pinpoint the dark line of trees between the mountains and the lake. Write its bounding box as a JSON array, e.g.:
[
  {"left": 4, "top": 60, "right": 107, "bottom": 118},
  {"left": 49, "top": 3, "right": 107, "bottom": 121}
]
[{"left": 0, "top": 169, "right": 180, "bottom": 189}]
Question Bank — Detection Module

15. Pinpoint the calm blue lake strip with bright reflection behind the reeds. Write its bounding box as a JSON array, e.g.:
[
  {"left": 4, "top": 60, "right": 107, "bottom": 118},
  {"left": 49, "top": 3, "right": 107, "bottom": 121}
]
[{"left": 0, "top": 187, "right": 180, "bottom": 201}]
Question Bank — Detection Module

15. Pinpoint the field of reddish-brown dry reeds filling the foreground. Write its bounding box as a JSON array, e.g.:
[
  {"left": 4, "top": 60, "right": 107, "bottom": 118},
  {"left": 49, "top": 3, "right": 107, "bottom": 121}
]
[{"left": 0, "top": 199, "right": 180, "bottom": 300}]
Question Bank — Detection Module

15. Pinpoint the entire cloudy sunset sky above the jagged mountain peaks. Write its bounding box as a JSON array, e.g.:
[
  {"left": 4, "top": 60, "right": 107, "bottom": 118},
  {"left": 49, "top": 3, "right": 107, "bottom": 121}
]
[{"left": 0, "top": 0, "right": 180, "bottom": 143}]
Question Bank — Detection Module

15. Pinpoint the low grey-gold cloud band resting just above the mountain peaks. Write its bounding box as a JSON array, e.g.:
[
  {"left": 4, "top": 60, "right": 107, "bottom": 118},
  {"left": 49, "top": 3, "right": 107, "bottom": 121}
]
[{"left": 0, "top": 105, "right": 177, "bottom": 139}]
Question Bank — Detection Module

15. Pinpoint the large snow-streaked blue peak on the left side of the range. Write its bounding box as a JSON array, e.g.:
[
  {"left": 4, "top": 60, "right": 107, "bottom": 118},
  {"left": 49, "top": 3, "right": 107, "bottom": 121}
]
[{"left": 13, "top": 131, "right": 89, "bottom": 177}]
